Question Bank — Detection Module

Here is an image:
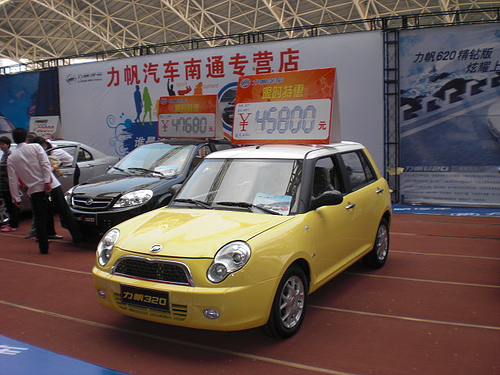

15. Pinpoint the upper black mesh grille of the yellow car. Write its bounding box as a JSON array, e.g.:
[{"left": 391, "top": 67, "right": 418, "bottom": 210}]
[{"left": 112, "top": 255, "right": 193, "bottom": 286}]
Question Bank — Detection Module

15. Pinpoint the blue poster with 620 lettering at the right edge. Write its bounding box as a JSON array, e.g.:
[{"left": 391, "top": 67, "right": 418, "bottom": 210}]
[{"left": 400, "top": 24, "right": 500, "bottom": 206}]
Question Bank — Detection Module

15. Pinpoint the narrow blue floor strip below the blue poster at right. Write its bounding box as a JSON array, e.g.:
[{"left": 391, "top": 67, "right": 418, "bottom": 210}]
[{"left": 392, "top": 204, "right": 500, "bottom": 217}]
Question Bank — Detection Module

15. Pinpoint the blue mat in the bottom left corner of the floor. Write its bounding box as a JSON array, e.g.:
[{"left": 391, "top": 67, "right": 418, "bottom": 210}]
[{"left": 0, "top": 335, "right": 125, "bottom": 375}]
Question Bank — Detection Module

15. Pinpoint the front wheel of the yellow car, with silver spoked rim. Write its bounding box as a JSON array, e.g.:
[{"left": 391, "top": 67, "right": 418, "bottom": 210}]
[{"left": 265, "top": 265, "right": 309, "bottom": 339}]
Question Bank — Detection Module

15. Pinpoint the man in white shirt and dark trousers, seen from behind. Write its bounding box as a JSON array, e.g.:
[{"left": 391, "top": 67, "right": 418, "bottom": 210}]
[{"left": 7, "top": 128, "right": 83, "bottom": 254}]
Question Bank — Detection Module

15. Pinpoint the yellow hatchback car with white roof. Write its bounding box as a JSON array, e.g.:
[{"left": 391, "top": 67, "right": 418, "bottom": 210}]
[{"left": 93, "top": 142, "right": 391, "bottom": 338}]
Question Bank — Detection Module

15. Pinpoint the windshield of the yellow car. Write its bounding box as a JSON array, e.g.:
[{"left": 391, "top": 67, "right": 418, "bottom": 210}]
[{"left": 175, "top": 159, "right": 302, "bottom": 215}]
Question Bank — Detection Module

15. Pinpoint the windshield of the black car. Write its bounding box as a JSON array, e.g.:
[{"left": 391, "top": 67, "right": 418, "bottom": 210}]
[{"left": 109, "top": 143, "right": 195, "bottom": 177}]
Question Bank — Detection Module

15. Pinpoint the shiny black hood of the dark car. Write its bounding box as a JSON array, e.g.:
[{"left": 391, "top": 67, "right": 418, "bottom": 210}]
[{"left": 73, "top": 174, "right": 174, "bottom": 197}]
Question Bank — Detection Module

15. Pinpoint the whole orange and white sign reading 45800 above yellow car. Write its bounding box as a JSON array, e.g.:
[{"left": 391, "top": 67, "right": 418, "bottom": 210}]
[{"left": 232, "top": 68, "right": 340, "bottom": 144}]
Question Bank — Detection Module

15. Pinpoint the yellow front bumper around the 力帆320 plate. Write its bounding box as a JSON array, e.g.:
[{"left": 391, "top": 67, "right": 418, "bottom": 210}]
[{"left": 92, "top": 267, "right": 278, "bottom": 331}]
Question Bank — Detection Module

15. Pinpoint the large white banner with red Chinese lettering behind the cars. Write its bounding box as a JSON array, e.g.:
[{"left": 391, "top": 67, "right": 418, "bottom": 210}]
[{"left": 59, "top": 31, "right": 384, "bottom": 169}]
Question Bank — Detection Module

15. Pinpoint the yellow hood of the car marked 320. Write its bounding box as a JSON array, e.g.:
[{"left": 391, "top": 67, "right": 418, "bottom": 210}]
[{"left": 116, "top": 208, "right": 294, "bottom": 258}]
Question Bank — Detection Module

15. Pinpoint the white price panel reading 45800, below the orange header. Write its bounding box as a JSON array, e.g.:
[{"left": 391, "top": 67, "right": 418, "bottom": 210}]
[{"left": 233, "top": 99, "right": 332, "bottom": 141}]
